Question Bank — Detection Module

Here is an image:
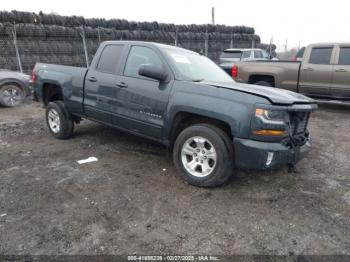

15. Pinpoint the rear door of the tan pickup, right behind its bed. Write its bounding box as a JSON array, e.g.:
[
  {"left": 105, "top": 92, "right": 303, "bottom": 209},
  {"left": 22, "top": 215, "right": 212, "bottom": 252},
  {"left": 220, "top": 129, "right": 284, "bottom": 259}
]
[{"left": 299, "top": 45, "right": 335, "bottom": 97}]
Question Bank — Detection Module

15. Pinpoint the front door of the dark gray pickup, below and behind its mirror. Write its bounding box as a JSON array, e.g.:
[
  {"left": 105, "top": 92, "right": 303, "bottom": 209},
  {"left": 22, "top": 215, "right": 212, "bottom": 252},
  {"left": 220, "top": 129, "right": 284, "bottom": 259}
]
[{"left": 113, "top": 45, "right": 173, "bottom": 140}]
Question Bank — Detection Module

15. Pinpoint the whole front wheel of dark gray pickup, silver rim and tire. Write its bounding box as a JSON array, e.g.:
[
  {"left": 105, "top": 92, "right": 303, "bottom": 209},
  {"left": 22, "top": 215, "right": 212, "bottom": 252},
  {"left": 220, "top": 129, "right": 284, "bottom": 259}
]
[{"left": 173, "top": 124, "right": 234, "bottom": 187}]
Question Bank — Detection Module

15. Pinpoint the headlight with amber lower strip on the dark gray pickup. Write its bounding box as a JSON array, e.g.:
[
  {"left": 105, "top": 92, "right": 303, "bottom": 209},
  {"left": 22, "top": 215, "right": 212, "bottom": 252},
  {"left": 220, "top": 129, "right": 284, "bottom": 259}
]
[{"left": 252, "top": 108, "right": 289, "bottom": 137}]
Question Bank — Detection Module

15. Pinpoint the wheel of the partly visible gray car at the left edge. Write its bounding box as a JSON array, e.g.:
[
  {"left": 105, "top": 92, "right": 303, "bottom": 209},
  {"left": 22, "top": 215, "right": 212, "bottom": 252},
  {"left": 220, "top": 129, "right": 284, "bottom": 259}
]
[{"left": 0, "top": 84, "right": 25, "bottom": 107}]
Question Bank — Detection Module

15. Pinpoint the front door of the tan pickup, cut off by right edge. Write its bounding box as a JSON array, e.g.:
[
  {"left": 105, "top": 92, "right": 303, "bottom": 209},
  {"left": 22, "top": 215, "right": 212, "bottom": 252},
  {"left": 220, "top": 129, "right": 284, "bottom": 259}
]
[{"left": 331, "top": 45, "right": 350, "bottom": 99}]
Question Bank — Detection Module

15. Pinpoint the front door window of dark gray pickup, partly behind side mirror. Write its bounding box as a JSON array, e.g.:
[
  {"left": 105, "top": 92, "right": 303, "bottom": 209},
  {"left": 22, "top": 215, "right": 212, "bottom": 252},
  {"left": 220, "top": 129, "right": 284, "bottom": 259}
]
[{"left": 124, "top": 46, "right": 163, "bottom": 77}]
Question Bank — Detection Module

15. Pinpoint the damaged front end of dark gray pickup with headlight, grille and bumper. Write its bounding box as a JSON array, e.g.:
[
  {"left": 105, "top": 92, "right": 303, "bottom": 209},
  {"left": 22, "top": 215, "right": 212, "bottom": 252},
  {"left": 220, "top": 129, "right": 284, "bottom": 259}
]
[{"left": 234, "top": 104, "right": 317, "bottom": 169}]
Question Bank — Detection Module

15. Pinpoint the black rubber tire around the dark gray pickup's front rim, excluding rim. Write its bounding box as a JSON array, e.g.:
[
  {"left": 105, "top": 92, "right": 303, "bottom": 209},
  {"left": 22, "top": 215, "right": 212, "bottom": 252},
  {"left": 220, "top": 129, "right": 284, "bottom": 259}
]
[{"left": 173, "top": 124, "right": 234, "bottom": 187}]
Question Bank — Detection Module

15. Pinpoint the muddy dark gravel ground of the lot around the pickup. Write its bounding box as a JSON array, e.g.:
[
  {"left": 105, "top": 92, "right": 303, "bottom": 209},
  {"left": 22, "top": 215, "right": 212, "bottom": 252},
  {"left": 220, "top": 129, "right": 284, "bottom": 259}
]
[{"left": 0, "top": 101, "right": 350, "bottom": 255}]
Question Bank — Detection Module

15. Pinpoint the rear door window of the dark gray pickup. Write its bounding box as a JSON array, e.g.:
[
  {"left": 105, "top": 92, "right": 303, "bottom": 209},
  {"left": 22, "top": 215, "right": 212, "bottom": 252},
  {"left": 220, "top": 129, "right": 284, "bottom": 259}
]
[{"left": 96, "top": 45, "right": 124, "bottom": 74}]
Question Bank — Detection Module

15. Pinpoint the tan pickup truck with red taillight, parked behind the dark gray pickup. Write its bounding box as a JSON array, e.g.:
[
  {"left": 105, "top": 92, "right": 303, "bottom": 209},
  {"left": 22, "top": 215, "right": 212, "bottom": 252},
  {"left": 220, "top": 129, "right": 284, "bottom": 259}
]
[{"left": 224, "top": 43, "right": 350, "bottom": 101}]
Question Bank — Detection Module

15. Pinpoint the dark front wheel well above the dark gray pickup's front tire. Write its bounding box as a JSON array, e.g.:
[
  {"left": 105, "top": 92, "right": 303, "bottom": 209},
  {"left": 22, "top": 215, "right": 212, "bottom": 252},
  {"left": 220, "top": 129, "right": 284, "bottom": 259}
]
[{"left": 170, "top": 112, "right": 232, "bottom": 148}]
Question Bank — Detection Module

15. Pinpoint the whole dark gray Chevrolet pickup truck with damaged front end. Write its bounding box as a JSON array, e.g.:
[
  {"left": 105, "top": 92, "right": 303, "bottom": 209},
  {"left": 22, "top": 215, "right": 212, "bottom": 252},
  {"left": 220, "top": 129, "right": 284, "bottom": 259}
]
[{"left": 32, "top": 41, "right": 317, "bottom": 187}]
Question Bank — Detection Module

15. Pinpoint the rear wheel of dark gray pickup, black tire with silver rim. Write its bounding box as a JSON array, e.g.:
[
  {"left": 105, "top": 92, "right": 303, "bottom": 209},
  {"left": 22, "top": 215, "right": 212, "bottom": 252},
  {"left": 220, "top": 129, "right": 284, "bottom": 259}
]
[{"left": 46, "top": 101, "right": 74, "bottom": 139}]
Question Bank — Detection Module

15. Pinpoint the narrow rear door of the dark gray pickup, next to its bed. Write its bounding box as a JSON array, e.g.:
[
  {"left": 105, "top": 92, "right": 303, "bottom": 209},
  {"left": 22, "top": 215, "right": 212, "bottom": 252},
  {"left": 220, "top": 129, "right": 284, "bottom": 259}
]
[{"left": 84, "top": 44, "right": 125, "bottom": 123}]
